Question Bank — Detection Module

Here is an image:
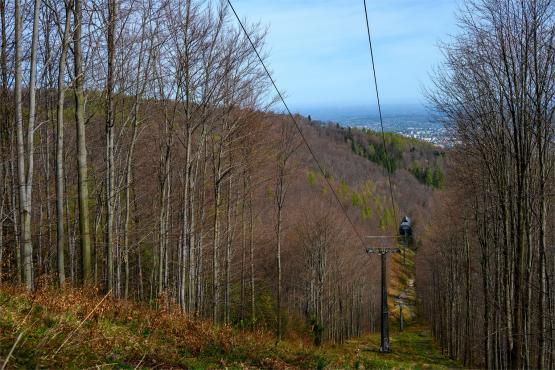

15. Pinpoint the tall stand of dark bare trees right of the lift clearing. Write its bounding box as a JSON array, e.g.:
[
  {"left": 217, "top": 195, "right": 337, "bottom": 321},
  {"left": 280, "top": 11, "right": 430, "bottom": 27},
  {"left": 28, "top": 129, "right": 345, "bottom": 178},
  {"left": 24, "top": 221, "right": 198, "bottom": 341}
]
[{"left": 419, "top": 0, "right": 555, "bottom": 369}]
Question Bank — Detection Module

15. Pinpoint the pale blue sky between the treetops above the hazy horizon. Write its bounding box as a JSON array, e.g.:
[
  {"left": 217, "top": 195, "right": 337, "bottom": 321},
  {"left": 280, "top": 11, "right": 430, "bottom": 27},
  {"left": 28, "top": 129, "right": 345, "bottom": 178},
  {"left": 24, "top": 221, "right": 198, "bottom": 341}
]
[{"left": 233, "top": 0, "right": 457, "bottom": 112}]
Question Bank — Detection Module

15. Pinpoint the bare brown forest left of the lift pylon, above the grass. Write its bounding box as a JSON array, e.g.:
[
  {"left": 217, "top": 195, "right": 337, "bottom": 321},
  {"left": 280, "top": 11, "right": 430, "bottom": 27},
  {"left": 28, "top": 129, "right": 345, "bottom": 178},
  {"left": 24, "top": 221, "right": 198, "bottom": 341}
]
[{"left": 0, "top": 0, "right": 439, "bottom": 352}]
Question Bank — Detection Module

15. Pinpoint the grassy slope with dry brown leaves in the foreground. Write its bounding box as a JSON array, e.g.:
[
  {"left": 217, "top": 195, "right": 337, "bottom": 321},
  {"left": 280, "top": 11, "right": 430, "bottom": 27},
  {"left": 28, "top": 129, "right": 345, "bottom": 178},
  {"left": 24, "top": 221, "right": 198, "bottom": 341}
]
[{"left": 0, "top": 287, "right": 457, "bottom": 368}]
